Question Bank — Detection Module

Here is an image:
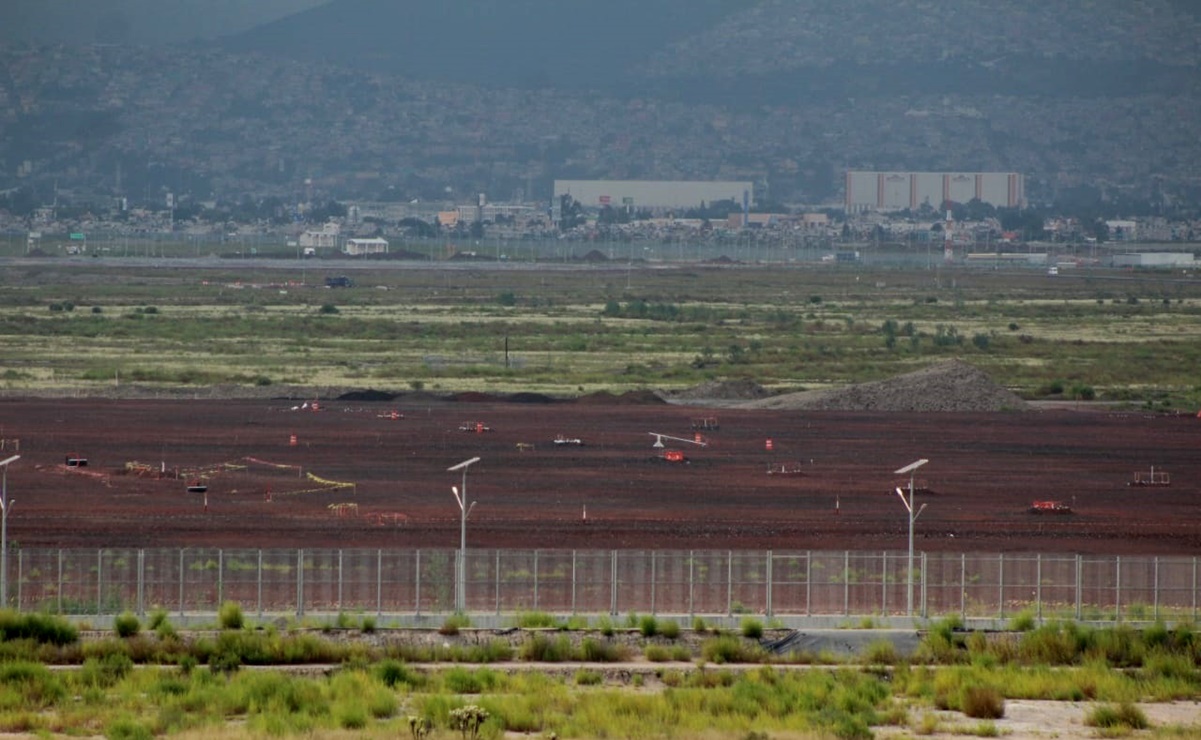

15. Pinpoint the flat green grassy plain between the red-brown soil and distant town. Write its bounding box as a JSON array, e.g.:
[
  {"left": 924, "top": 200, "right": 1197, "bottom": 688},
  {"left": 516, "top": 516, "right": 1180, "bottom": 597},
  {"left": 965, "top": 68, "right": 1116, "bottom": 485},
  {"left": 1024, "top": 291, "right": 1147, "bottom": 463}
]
[{"left": 0, "top": 258, "right": 1201, "bottom": 408}]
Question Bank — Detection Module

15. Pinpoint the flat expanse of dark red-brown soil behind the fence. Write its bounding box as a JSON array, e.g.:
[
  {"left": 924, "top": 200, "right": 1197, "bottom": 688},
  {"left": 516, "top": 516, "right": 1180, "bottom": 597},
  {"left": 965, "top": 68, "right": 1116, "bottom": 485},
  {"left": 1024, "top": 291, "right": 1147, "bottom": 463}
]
[{"left": 0, "top": 399, "right": 1201, "bottom": 555}]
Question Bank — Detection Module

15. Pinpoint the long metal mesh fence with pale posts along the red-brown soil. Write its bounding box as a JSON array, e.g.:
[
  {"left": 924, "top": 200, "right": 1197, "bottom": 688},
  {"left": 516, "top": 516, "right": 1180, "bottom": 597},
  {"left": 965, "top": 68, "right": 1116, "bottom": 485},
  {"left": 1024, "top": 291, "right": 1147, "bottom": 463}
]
[{"left": 4, "top": 548, "right": 1199, "bottom": 622}]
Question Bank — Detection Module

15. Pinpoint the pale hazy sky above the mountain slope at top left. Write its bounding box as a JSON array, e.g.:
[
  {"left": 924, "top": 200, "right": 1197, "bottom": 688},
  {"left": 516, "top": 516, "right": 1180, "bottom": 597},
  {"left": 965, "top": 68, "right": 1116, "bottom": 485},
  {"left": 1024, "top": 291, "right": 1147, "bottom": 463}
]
[{"left": 0, "top": 0, "right": 328, "bottom": 44}]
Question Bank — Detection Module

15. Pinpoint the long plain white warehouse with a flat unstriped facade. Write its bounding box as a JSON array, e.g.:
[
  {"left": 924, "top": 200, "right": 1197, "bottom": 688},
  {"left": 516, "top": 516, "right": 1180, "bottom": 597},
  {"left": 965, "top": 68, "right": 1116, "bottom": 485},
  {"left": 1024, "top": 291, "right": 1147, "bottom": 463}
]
[{"left": 554, "top": 180, "right": 754, "bottom": 211}]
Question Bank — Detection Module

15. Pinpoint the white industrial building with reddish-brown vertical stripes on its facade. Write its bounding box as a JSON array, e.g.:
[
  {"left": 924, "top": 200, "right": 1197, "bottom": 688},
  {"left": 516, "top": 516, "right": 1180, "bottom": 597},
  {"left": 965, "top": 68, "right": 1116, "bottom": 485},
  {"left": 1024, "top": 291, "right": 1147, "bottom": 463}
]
[{"left": 847, "top": 171, "right": 1026, "bottom": 214}]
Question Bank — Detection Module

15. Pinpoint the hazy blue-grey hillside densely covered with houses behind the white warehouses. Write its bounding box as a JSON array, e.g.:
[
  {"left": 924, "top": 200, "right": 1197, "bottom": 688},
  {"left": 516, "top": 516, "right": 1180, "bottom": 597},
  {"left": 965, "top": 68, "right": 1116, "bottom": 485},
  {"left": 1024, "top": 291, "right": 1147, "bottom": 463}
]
[{"left": 0, "top": 0, "right": 1201, "bottom": 205}]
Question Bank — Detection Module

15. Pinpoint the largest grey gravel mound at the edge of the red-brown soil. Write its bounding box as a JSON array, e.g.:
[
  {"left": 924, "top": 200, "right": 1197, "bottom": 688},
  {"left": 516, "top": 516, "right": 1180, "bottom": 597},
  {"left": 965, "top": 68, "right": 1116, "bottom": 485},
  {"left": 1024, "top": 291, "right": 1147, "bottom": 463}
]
[{"left": 742, "top": 359, "right": 1029, "bottom": 411}]
